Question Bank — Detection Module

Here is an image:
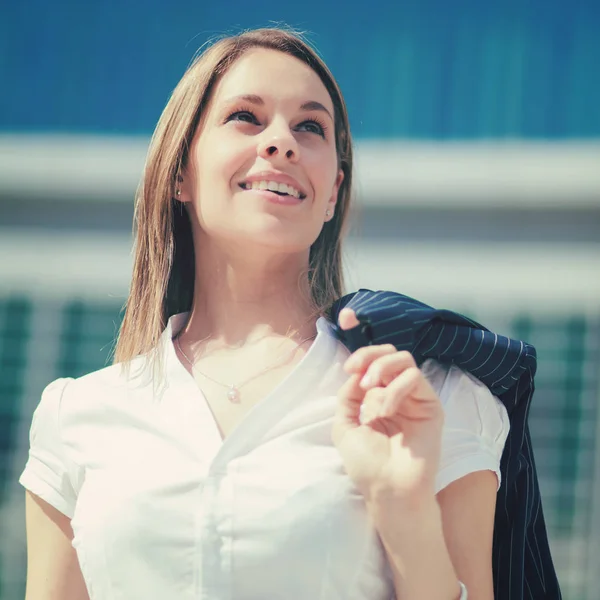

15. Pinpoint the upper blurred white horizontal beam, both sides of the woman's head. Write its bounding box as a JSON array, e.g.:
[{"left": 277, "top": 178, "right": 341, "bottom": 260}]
[{"left": 0, "top": 134, "right": 600, "bottom": 210}]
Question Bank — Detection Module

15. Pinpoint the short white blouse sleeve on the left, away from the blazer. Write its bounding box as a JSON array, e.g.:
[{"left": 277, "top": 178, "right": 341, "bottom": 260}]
[{"left": 19, "top": 378, "right": 76, "bottom": 518}]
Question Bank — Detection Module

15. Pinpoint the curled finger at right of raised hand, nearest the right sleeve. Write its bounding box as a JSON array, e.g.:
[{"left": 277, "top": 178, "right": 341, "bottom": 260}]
[{"left": 379, "top": 367, "right": 441, "bottom": 419}]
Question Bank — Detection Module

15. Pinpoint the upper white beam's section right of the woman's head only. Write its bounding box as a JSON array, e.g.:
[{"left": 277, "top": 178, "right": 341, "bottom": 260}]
[{"left": 356, "top": 141, "right": 600, "bottom": 209}]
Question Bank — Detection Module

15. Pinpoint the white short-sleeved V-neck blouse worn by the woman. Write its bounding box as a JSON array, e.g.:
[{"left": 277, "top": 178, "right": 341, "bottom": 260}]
[{"left": 20, "top": 315, "right": 509, "bottom": 600}]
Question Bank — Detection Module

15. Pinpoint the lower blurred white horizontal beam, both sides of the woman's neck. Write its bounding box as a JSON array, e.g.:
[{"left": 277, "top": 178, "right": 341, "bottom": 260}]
[{"left": 0, "top": 228, "right": 600, "bottom": 318}]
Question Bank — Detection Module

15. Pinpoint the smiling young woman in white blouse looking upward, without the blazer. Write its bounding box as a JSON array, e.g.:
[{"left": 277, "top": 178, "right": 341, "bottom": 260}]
[{"left": 21, "top": 29, "right": 508, "bottom": 600}]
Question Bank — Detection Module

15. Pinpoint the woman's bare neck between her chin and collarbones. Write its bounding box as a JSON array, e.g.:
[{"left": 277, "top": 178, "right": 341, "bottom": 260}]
[{"left": 182, "top": 243, "right": 317, "bottom": 345}]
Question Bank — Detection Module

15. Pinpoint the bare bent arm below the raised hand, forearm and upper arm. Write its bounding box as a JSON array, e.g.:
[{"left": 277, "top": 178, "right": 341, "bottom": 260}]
[{"left": 374, "top": 471, "right": 497, "bottom": 600}]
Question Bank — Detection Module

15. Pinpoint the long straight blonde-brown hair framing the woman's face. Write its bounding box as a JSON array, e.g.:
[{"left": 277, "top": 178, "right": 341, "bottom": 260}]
[{"left": 114, "top": 29, "right": 352, "bottom": 362}]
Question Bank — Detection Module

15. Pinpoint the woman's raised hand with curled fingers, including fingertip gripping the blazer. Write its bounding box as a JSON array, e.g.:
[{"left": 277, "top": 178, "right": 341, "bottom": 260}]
[{"left": 332, "top": 309, "right": 444, "bottom": 502}]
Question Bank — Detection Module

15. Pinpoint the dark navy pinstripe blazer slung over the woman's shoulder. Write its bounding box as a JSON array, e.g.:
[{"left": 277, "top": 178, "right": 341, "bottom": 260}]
[{"left": 329, "top": 290, "right": 561, "bottom": 600}]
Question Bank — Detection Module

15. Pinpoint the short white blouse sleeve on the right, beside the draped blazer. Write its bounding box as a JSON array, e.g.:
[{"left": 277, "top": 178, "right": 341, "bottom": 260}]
[{"left": 422, "top": 360, "right": 510, "bottom": 493}]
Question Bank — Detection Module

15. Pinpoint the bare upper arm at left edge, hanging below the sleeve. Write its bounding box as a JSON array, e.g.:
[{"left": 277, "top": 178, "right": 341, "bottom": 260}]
[{"left": 25, "top": 492, "right": 89, "bottom": 600}]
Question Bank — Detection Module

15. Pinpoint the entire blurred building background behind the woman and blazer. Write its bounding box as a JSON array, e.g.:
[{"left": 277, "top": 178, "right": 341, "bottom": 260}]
[{"left": 0, "top": 0, "right": 600, "bottom": 600}]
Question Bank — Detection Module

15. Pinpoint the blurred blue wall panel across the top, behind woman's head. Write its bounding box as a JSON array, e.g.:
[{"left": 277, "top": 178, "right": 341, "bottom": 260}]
[{"left": 0, "top": 0, "right": 600, "bottom": 139}]
